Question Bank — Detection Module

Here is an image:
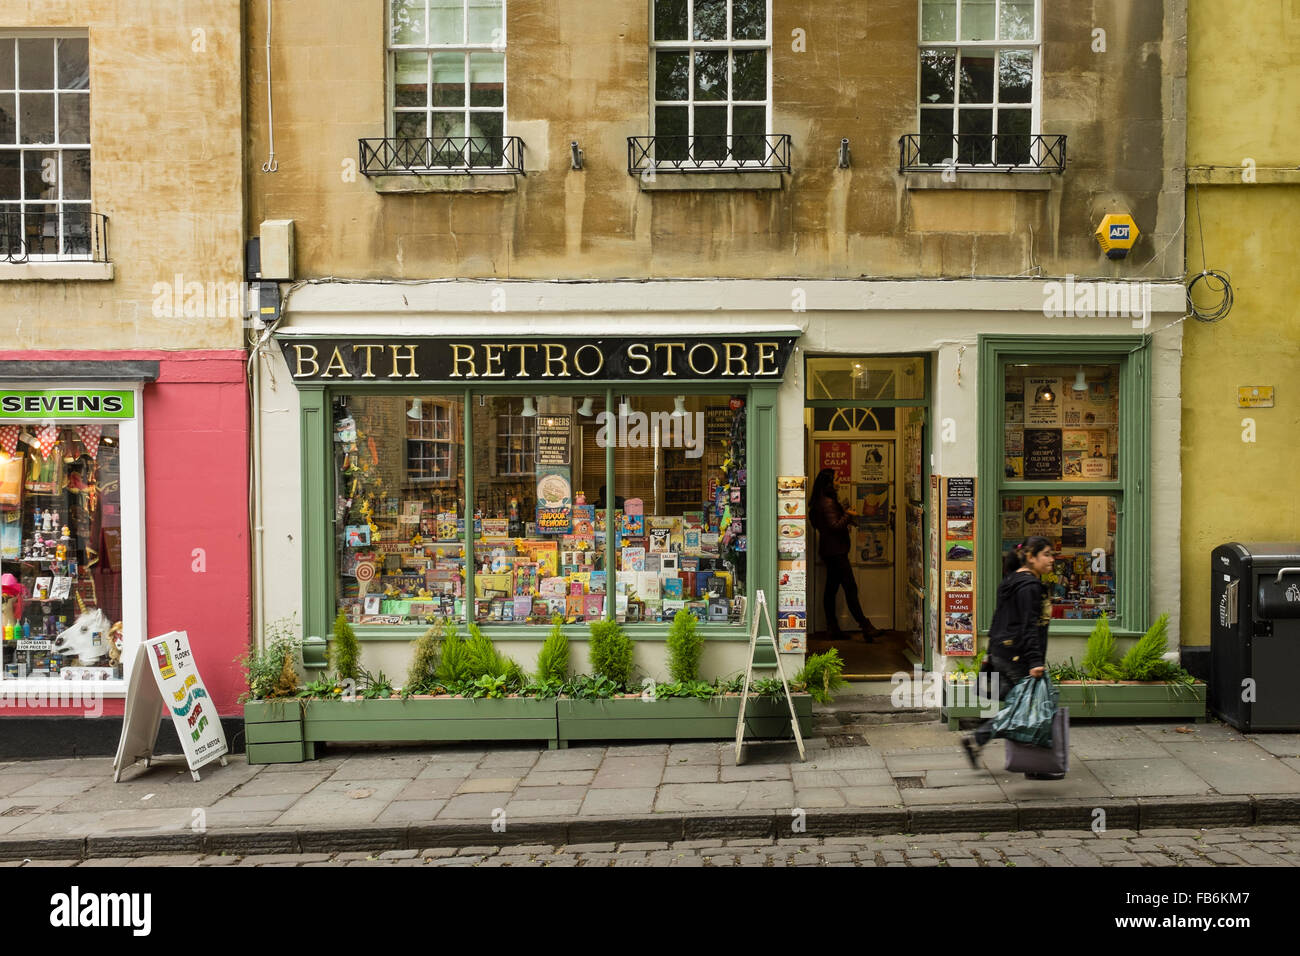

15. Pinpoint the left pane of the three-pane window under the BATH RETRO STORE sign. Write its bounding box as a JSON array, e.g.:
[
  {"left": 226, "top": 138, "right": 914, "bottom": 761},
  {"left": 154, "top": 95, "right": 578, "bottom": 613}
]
[{"left": 334, "top": 395, "right": 465, "bottom": 626}]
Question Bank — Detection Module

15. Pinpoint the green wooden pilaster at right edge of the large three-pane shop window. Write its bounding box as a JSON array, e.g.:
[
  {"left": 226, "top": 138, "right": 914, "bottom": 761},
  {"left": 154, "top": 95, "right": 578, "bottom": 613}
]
[{"left": 745, "top": 382, "right": 780, "bottom": 667}]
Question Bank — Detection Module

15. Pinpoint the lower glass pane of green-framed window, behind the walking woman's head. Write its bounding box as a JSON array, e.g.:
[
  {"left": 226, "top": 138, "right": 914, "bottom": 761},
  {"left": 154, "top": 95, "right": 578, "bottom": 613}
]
[{"left": 1002, "top": 494, "right": 1118, "bottom": 620}]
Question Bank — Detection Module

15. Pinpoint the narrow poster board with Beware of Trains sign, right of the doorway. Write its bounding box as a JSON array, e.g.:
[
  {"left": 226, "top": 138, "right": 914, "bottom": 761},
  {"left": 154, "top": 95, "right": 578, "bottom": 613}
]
[{"left": 936, "top": 477, "right": 978, "bottom": 657}]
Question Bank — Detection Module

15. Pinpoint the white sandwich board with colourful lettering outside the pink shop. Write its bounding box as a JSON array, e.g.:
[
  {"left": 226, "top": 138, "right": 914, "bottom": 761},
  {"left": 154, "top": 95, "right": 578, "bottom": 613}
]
[{"left": 113, "top": 631, "right": 226, "bottom": 783}]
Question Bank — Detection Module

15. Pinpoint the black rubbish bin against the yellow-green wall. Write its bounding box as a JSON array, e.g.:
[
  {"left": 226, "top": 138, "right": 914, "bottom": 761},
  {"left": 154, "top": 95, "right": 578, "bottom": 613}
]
[{"left": 1209, "top": 541, "right": 1300, "bottom": 732}]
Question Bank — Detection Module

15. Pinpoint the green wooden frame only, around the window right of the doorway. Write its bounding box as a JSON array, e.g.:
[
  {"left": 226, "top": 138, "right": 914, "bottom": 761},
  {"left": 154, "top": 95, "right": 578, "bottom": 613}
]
[{"left": 976, "top": 336, "right": 1152, "bottom": 636}]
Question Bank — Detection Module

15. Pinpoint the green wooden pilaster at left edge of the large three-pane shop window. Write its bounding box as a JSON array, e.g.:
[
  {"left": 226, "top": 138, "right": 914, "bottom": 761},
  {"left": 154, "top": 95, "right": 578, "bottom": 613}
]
[{"left": 298, "top": 386, "right": 334, "bottom": 647}]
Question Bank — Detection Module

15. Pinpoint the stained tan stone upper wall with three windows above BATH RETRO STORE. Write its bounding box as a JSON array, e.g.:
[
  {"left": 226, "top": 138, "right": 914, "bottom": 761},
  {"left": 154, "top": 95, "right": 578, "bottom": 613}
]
[{"left": 246, "top": 0, "right": 1183, "bottom": 278}]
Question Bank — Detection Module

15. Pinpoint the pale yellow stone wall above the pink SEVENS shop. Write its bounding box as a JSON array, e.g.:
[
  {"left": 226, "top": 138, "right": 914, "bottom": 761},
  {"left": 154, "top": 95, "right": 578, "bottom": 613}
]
[{"left": 0, "top": 0, "right": 244, "bottom": 349}]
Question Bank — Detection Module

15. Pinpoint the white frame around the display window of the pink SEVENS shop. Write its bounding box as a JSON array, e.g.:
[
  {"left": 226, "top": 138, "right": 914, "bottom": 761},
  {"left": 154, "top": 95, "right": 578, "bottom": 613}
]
[{"left": 0, "top": 381, "right": 148, "bottom": 702}]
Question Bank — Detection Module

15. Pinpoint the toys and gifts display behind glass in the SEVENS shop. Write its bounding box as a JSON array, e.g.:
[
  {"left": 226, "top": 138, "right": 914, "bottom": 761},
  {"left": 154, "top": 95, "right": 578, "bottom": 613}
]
[{"left": 0, "top": 423, "right": 122, "bottom": 680}]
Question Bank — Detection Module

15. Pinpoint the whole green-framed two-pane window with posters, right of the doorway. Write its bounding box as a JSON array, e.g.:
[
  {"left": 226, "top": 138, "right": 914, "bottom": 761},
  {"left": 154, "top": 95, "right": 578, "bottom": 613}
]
[{"left": 976, "top": 336, "right": 1151, "bottom": 631}]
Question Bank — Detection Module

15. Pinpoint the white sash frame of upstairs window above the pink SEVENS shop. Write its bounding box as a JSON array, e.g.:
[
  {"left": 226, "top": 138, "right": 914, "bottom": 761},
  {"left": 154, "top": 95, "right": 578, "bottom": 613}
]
[{"left": 0, "top": 30, "right": 96, "bottom": 263}]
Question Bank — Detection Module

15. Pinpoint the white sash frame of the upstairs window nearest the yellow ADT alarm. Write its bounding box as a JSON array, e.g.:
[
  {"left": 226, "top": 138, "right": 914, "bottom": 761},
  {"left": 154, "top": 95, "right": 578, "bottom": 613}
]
[{"left": 917, "top": 0, "right": 1043, "bottom": 169}]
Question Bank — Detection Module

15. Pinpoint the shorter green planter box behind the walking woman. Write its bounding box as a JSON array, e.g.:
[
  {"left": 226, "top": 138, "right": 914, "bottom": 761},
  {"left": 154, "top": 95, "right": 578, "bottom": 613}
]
[{"left": 944, "top": 682, "right": 1206, "bottom": 730}]
